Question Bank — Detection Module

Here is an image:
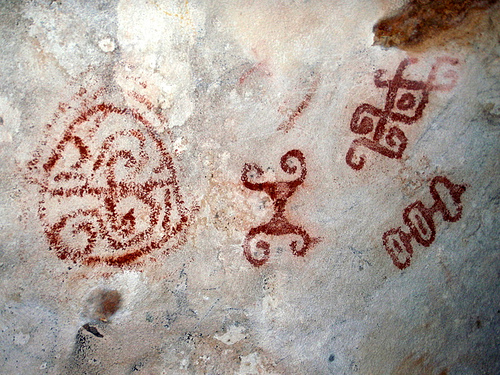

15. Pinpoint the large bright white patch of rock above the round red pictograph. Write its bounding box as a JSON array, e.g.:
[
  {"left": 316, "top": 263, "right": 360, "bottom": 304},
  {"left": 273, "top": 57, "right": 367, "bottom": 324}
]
[{"left": 117, "top": 0, "right": 195, "bottom": 126}]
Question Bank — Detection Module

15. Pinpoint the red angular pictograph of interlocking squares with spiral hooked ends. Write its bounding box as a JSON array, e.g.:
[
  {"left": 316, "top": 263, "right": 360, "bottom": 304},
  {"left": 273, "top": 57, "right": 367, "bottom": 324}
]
[{"left": 346, "top": 57, "right": 458, "bottom": 170}]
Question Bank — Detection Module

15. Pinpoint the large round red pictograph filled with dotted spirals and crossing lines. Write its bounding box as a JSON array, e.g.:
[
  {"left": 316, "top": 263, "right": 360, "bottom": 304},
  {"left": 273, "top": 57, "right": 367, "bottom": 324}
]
[{"left": 29, "top": 88, "right": 197, "bottom": 267}]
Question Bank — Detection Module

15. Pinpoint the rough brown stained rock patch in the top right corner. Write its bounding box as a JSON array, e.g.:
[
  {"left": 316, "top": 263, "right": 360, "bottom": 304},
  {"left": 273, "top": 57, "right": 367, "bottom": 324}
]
[{"left": 373, "top": 0, "right": 498, "bottom": 50}]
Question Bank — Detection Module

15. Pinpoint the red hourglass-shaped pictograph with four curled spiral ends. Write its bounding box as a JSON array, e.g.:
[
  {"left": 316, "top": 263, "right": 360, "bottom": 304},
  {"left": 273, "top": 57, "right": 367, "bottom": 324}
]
[{"left": 241, "top": 150, "right": 318, "bottom": 267}]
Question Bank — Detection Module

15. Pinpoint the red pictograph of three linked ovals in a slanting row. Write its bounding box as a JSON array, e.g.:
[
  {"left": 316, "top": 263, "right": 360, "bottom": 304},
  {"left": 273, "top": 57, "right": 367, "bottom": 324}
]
[{"left": 382, "top": 176, "right": 465, "bottom": 270}]
